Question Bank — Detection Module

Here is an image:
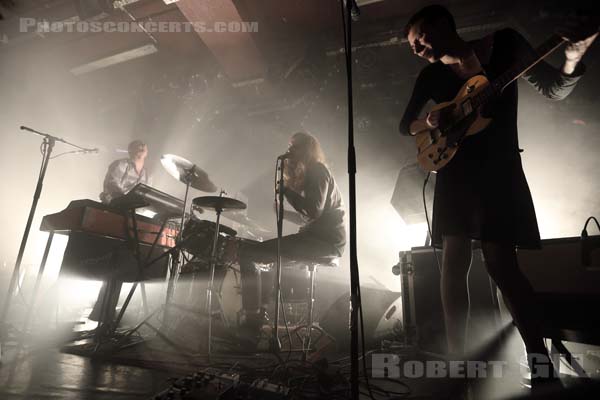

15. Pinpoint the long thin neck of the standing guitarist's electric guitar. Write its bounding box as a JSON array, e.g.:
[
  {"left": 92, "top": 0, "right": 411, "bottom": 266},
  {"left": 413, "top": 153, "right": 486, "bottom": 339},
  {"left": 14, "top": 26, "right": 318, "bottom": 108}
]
[{"left": 474, "top": 35, "right": 565, "bottom": 106}]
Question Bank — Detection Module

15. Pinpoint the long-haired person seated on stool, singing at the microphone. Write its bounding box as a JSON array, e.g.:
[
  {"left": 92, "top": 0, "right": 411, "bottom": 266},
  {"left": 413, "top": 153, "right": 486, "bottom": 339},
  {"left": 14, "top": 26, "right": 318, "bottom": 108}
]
[{"left": 238, "top": 132, "right": 346, "bottom": 338}]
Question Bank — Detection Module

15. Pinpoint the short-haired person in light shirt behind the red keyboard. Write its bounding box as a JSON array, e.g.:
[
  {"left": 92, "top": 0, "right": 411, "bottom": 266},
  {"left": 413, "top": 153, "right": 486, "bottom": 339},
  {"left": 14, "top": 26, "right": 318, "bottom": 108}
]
[{"left": 100, "top": 140, "right": 150, "bottom": 204}]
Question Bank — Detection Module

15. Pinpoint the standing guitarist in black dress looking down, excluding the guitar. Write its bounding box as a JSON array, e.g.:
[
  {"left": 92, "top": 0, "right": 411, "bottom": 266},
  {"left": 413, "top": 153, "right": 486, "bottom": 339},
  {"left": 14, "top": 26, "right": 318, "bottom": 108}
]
[{"left": 400, "top": 5, "right": 597, "bottom": 388}]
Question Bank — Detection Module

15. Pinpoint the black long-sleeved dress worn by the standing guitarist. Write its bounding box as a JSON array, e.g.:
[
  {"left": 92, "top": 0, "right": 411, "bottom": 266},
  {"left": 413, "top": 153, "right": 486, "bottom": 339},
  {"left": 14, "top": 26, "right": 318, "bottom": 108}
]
[{"left": 400, "top": 29, "right": 583, "bottom": 248}]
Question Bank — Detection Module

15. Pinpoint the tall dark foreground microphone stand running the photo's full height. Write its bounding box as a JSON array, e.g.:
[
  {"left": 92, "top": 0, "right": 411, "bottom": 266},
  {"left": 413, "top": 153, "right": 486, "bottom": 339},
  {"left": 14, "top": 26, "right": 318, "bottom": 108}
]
[{"left": 341, "top": 0, "right": 360, "bottom": 400}]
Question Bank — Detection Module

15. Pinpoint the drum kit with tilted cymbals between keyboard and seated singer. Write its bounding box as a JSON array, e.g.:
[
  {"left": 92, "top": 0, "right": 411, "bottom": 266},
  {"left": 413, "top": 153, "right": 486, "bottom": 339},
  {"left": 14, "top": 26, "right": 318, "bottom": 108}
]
[{"left": 161, "top": 154, "right": 268, "bottom": 356}]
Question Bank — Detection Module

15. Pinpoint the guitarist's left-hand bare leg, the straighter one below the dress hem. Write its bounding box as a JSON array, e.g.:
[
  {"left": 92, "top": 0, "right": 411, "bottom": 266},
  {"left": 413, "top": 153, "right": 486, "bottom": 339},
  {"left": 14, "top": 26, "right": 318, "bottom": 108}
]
[{"left": 440, "top": 236, "right": 471, "bottom": 354}]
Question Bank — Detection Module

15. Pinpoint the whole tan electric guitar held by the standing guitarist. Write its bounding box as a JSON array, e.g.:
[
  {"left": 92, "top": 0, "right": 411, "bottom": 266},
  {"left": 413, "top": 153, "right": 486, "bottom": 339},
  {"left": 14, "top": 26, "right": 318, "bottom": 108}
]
[{"left": 410, "top": 27, "right": 596, "bottom": 171}]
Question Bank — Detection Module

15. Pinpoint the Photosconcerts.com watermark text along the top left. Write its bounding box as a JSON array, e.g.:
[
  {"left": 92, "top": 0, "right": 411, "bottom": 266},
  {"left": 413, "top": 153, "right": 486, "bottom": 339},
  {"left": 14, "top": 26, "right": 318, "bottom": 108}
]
[{"left": 19, "top": 18, "right": 258, "bottom": 33}]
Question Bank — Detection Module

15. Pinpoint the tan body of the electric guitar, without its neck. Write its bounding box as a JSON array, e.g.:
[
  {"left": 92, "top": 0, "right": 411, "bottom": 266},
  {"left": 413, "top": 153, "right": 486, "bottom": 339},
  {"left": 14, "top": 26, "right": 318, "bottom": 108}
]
[{"left": 410, "top": 75, "right": 492, "bottom": 171}]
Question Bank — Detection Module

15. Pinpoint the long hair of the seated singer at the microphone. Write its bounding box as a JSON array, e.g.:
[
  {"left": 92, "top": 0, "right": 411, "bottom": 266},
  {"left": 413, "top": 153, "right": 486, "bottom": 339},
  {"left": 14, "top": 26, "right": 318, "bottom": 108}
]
[{"left": 284, "top": 132, "right": 325, "bottom": 193}]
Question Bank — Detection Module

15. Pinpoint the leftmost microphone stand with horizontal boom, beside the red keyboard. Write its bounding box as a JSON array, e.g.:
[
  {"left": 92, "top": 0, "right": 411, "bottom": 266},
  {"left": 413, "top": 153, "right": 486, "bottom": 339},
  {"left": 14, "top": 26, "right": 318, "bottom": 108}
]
[{"left": 0, "top": 126, "right": 96, "bottom": 342}]
